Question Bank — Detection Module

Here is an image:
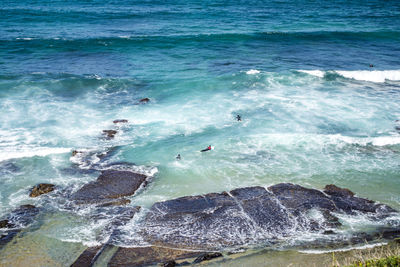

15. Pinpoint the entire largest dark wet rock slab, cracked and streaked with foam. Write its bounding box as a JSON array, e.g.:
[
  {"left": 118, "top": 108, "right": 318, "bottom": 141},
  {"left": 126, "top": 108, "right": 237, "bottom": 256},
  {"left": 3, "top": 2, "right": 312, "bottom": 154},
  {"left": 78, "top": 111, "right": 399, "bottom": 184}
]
[{"left": 142, "top": 183, "right": 395, "bottom": 250}]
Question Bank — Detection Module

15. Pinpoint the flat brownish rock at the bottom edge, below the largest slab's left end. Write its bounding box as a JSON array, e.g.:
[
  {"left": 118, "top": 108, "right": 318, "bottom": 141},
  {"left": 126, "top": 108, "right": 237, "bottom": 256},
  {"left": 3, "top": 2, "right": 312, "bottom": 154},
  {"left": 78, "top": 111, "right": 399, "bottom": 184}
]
[{"left": 108, "top": 246, "right": 201, "bottom": 267}]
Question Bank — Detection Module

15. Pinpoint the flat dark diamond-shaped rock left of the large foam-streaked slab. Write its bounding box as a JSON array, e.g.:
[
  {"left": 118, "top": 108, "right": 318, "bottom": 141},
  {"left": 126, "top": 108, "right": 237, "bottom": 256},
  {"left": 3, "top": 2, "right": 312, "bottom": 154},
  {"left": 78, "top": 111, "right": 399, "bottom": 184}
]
[{"left": 71, "top": 170, "right": 147, "bottom": 204}]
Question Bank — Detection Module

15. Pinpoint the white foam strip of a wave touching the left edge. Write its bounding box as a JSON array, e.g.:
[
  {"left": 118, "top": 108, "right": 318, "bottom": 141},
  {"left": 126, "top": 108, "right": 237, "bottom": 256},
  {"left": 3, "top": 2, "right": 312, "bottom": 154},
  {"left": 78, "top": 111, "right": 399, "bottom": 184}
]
[{"left": 0, "top": 147, "right": 71, "bottom": 161}]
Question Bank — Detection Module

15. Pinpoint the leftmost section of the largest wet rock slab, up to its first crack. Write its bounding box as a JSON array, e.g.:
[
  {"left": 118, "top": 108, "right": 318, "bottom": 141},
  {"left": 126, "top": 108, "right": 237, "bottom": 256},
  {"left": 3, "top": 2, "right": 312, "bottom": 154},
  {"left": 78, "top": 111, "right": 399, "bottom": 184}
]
[{"left": 143, "top": 192, "right": 254, "bottom": 250}]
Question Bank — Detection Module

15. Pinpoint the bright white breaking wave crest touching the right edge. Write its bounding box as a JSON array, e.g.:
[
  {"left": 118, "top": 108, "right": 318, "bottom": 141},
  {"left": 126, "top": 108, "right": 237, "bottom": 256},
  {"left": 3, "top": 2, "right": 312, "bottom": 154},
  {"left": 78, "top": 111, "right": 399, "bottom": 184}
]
[{"left": 298, "top": 70, "right": 400, "bottom": 83}]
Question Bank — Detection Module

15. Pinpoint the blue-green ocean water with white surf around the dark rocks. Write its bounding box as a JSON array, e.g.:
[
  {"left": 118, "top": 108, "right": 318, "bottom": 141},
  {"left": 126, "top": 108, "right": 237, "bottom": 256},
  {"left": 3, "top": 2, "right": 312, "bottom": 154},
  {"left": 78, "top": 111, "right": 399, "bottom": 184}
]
[{"left": 0, "top": 0, "right": 400, "bottom": 266}]
